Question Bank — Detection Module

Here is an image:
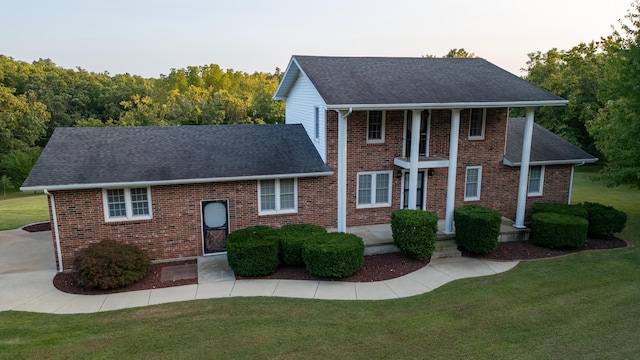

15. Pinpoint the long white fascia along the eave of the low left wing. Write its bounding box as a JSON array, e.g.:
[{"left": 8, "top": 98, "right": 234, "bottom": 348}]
[{"left": 20, "top": 171, "right": 333, "bottom": 191}]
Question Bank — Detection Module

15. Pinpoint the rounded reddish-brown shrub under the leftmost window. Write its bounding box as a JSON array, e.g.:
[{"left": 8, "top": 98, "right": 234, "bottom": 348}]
[{"left": 73, "top": 240, "right": 151, "bottom": 290}]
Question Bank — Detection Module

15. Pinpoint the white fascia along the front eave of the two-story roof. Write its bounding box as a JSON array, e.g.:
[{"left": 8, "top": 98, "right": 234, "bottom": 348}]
[{"left": 327, "top": 100, "right": 569, "bottom": 110}]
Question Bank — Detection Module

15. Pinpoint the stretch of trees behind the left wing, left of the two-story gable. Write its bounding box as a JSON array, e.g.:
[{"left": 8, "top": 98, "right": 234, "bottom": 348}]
[{"left": 0, "top": 55, "right": 284, "bottom": 187}]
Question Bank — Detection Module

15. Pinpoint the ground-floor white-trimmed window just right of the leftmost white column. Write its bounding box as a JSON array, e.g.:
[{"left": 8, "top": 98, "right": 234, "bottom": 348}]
[{"left": 356, "top": 171, "right": 392, "bottom": 208}]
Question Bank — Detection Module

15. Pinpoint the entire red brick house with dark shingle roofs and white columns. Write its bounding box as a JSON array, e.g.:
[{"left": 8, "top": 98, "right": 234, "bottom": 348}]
[{"left": 21, "top": 56, "right": 597, "bottom": 271}]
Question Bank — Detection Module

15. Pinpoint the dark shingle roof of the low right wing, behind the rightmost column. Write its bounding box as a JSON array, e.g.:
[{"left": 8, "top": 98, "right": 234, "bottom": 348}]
[{"left": 504, "top": 118, "right": 598, "bottom": 166}]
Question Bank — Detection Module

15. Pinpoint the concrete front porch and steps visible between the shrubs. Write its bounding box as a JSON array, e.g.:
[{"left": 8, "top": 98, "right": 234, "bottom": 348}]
[{"left": 328, "top": 217, "right": 531, "bottom": 259}]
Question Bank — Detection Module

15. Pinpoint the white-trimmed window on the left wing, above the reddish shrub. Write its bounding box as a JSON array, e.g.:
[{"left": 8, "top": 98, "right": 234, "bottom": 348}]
[{"left": 102, "top": 187, "right": 152, "bottom": 221}]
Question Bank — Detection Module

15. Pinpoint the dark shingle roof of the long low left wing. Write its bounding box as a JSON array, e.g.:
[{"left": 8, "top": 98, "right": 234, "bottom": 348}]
[{"left": 22, "top": 125, "right": 331, "bottom": 190}]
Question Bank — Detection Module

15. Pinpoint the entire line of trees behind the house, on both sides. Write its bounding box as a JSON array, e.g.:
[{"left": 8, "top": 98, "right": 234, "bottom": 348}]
[{"left": 0, "top": 2, "right": 640, "bottom": 188}]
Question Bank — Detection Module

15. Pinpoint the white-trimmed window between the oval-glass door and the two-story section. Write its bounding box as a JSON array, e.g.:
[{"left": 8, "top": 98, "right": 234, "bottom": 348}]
[{"left": 258, "top": 178, "right": 298, "bottom": 215}]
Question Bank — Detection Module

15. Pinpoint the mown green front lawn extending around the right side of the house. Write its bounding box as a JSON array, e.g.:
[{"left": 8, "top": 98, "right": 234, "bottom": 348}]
[{"left": 0, "top": 168, "right": 640, "bottom": 359}]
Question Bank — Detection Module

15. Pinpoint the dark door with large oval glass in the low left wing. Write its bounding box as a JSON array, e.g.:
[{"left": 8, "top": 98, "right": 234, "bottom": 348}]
[{"left": 202, "top": 200, "right": 229, "bottom": 255}]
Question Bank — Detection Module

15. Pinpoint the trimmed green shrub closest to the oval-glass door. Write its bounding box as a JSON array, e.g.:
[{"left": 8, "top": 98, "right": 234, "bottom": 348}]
[{"left": 227, "top": 226, "right": 280, "bottom": 277}]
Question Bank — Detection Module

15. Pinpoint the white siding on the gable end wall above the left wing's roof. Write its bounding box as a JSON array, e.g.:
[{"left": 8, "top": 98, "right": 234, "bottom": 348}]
[{"left": 285, "top": 74, "right": 327, "bottom": 162}]
